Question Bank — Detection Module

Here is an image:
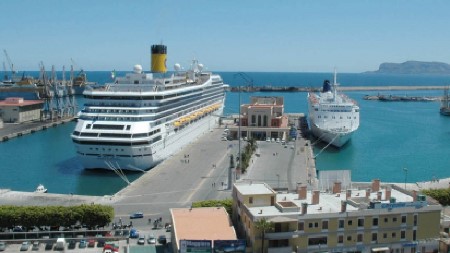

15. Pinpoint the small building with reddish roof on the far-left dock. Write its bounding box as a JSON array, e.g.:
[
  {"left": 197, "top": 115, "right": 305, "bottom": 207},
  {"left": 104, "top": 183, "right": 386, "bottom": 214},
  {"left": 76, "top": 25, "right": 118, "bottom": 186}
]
[{"left": 0, "top": 97, "right": 44, "bottom": 123}]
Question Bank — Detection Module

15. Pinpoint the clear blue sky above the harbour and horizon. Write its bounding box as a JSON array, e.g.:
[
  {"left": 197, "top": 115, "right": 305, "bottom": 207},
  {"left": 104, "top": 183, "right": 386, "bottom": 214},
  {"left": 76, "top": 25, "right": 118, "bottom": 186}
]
[{"left": 0, "top": 0, "right": 450, "bottom": 73}]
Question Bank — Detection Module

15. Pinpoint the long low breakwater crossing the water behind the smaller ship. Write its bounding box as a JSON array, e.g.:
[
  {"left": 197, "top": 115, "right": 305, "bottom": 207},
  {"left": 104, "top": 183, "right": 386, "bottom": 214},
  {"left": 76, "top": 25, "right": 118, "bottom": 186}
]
[{"left": 229, "top": 85, "right": 447, "bottom": 92}]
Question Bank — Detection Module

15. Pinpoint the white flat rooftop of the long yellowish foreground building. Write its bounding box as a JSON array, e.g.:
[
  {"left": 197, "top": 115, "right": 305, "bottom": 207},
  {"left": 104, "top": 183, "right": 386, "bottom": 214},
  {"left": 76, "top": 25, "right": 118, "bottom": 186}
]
[{"left": 235, "top": 182, "right": 438, "bottom": 217}]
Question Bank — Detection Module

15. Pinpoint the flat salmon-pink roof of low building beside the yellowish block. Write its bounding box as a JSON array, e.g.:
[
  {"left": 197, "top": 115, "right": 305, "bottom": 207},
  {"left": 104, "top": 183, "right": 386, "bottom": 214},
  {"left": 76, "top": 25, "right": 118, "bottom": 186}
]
[{"left": 170, "top": 207, "right": 237, "bottom": 252}]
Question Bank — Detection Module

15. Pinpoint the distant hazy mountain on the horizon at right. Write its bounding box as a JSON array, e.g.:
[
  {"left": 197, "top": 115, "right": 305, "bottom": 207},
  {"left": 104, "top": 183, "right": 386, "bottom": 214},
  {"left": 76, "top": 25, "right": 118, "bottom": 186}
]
[{"left": 366, "top": 61, "right": 450, "bottom": 75}]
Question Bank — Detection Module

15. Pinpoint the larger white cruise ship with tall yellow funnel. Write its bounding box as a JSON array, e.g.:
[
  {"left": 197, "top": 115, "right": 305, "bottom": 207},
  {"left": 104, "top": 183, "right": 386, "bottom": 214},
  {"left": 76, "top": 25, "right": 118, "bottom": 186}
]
[{"left": 71, "top": 45, "right": 227, "bottom": 171}]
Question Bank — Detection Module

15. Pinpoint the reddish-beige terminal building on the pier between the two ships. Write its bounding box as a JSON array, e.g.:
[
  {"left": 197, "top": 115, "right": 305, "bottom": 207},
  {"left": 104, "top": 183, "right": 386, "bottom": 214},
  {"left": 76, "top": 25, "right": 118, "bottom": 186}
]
[{"left": 227, "top": 97, "right": 290, "bottom": 141}]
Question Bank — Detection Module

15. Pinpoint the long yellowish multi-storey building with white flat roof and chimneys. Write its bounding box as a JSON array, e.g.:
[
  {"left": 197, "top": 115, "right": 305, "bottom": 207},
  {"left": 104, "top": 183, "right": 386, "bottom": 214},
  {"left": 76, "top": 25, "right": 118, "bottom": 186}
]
[{"left": 232, "top": 180, "right": 442, "bottom": 253}]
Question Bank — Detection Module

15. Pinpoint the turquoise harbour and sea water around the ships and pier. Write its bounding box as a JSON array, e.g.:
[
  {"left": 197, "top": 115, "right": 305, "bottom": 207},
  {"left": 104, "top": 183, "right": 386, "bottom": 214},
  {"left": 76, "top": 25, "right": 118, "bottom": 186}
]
[{"left": 0, "top": 71, "right": 450, "bottom": 195}]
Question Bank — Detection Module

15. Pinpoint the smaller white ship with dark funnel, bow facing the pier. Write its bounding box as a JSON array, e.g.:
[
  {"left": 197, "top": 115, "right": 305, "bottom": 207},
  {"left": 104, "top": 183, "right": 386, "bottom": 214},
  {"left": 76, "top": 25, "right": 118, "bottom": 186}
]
[{"left": 308, "top": 73, "right": 359, "bottom": 147}]
